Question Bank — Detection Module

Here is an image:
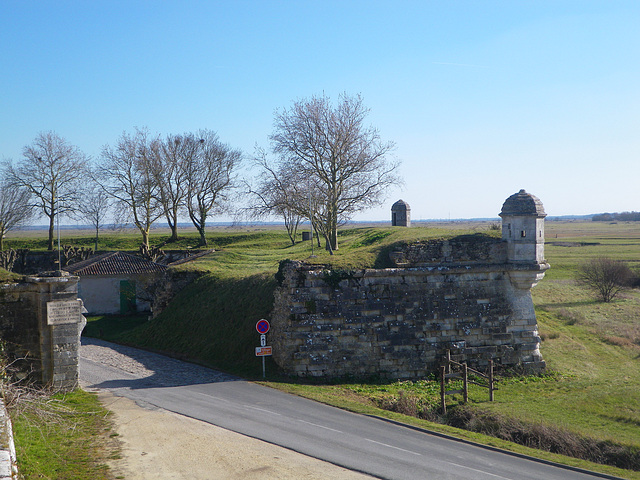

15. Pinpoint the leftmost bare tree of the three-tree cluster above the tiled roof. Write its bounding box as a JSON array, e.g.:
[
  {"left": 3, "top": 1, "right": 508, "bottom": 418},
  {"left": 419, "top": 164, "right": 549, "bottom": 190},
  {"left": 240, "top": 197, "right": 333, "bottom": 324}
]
[{"left": 98, "top": 130, "right": 164, "bottom": 247}]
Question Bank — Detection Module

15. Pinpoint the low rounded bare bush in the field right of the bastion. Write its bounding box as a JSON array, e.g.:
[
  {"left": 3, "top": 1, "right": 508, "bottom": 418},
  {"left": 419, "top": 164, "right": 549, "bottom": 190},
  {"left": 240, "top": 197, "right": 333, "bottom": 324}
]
[{"left": 576, "top": 257, "right": 633, "bottom": 302}]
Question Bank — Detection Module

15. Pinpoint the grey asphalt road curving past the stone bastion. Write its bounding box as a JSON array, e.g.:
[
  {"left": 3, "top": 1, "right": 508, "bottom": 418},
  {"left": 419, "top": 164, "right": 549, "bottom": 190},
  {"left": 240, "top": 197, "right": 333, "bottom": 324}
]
[{"left": 80, "top": 338, "right": 610, "bottom": 480}]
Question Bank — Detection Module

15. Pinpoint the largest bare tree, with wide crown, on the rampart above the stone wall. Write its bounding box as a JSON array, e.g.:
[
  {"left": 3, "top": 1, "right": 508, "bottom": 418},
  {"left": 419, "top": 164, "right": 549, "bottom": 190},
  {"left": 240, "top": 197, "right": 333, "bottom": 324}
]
[{"left": 270, "top": 94, "right": 399, "bottom": 252}]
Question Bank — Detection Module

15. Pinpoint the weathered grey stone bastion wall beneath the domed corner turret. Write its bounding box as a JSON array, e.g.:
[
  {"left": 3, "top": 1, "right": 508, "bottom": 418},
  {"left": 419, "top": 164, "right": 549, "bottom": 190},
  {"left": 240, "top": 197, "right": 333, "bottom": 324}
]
[{"left": 270, "top": 190, "right": 549, "bottom": 378}]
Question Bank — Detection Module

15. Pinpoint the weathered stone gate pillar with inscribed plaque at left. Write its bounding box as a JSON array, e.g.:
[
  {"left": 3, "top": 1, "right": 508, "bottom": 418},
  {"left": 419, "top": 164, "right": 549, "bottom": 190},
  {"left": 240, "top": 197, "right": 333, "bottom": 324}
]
[{"left": 0, "top": 276, "right": 86, "bottom": 390}]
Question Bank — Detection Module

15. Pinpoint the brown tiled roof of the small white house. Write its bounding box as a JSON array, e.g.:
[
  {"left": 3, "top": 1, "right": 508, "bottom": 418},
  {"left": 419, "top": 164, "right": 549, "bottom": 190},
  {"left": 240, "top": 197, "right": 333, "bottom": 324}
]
[{"left": 64, "top": 252, "right": 167, "bottom": 276}]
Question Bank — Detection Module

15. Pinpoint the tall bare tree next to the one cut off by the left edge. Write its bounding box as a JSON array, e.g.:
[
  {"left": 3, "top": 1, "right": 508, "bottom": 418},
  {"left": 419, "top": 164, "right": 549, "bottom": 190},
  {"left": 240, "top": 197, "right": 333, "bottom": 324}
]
[{"left": 8, "top": 132, "right": 87, "bottom": 250}]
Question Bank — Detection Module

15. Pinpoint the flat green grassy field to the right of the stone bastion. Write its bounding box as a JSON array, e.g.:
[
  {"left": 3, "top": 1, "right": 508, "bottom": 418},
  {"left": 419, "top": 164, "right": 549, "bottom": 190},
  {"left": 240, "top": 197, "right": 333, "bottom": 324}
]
[{"left": 524, "top": 223, "right": 640, "bottom": 447}]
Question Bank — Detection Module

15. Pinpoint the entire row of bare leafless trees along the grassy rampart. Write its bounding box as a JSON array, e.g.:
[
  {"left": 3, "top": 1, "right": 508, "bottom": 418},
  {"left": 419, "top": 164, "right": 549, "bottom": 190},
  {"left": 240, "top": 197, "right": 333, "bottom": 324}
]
[{"left": 0, "top": 94, "right": 400, "bottom": 252}]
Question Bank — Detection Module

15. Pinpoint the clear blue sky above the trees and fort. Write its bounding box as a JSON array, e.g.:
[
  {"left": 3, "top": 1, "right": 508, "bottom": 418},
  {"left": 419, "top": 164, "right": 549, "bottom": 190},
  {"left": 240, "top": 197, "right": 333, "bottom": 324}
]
[{"left": 0, "top": 0, "right": 640, "bottom": 220}]
